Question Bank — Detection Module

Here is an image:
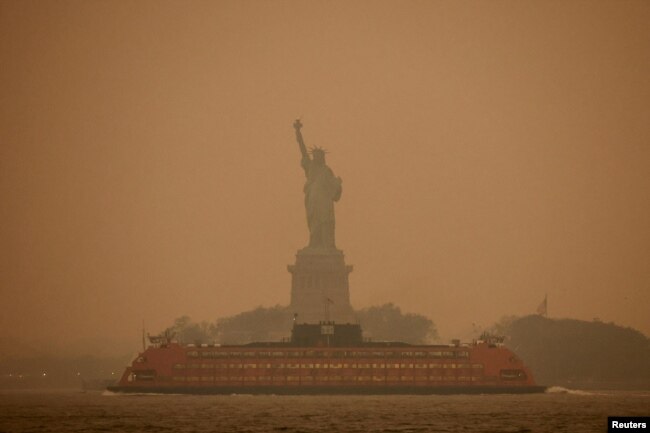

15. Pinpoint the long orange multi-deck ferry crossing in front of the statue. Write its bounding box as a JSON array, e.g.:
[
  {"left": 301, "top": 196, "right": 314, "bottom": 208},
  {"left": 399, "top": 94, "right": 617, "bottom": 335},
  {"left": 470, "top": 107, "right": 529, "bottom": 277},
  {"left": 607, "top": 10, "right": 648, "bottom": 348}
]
[{"left": 108, "top": 322, "right": 545, "bottom": 394}]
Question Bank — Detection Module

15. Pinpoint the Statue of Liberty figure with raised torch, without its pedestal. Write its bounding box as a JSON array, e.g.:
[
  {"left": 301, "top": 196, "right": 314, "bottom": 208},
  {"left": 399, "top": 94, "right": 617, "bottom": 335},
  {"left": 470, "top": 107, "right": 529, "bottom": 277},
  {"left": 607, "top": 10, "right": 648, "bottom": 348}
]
[{"left": 293, "top": 119, "right": 341, "bottom": 250}]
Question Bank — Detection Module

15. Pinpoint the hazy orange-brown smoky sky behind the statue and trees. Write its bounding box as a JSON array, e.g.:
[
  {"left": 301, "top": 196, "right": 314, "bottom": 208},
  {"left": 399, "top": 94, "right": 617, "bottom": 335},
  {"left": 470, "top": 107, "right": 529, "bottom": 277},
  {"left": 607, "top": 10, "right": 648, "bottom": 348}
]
[{"left": 0, "top": 0, "right": 650, "bottom": 350}]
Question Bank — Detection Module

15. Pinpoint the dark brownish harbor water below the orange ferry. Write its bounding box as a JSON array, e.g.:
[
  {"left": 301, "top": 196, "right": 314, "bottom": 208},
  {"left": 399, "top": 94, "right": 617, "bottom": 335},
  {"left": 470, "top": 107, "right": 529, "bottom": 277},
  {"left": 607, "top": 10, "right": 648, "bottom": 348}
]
[{"left": 0, "top": 387, "right": 650, "bottom": 433}]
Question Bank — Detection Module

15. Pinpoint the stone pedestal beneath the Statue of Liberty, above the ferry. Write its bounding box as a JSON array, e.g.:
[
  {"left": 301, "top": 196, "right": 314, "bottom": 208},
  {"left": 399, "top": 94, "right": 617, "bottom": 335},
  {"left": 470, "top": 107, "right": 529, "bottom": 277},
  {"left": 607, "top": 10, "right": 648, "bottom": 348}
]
[{"left": 287, "top": 248, "right": 354, "bottom": 323}]
